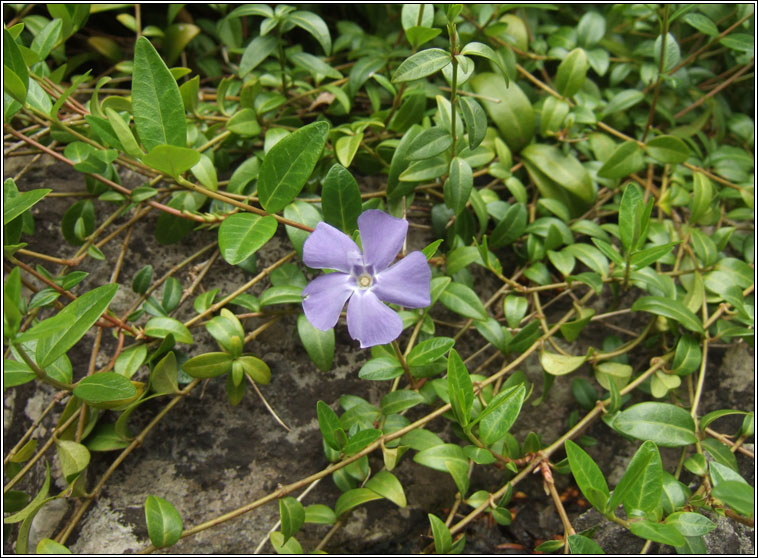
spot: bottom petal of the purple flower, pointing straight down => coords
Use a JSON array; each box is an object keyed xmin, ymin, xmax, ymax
[{"xmin": 347, "ymin": 290, "xmax": 403, "ymax": 349}]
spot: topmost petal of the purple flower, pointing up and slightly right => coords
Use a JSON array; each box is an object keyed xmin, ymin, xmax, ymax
[{"xmin": 358, "ymin": 209, "xmax": 408, "ymax": 273}]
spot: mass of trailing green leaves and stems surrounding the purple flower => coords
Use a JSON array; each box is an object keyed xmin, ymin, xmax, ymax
[{"xmin": 3, "ymin": 4, "xmax": 755, "ymax": 553}]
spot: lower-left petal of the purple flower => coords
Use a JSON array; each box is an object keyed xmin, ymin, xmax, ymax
[{"xmin": 303, "ymin": 273, "xmax": 355, "ymax": 331}]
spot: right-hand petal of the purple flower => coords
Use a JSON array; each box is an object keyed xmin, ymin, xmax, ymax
[{"xmin": 371, "ymin": 252, "xmax": 432, "ymax": 308}]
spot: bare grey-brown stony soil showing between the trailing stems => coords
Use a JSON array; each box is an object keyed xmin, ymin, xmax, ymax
[{"xmin": 4, "ymin": 156, "xmax": 755, "ymax": 554}]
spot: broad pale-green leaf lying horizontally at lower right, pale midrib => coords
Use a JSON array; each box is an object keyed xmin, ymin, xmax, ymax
[{"xmin": 613, "ymin": 401, "xmax": 697, "ymax": 448}]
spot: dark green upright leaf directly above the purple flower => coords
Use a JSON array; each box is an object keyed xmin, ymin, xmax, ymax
[{"xmin": 321, "ymin": 164, "xmax": 362, "ymax": 234}]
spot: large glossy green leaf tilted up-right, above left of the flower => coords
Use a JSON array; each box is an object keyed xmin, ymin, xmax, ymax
[{"xmin": 258, "ymin": 121, "xmax": 329, "ymax": 213}]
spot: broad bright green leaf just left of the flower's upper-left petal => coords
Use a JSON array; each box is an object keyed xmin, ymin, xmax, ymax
[{"xmin": 218, "ymin": 213, "xmax": 277, "ymax": 265}]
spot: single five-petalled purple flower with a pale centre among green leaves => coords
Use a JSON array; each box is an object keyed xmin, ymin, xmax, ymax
[{"xmin": 303, "ymin": 209, "xmax": 432, "ymax": 348}]
